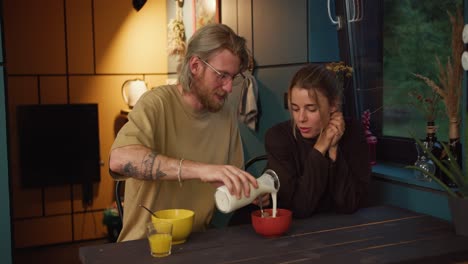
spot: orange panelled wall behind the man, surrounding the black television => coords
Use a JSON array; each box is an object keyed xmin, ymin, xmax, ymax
[{"xmin": 3, "ymin": 0, "xmax": 168, "ymax": 248}]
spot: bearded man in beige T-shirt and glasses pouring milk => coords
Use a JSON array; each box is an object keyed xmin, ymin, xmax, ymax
[{"xmin": 109, "ymin": 24, "xmax": 258, "ymax": 241}]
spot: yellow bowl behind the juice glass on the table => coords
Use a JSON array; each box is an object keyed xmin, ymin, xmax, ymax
[{"xmin": 151, "ymin": 209, "xmax": 195, "ymax": 245}]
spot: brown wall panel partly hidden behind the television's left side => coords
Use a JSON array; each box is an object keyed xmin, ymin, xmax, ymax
[{"xmin": 7, "ymin": 77, "xmax": 43, "ymax": 218}]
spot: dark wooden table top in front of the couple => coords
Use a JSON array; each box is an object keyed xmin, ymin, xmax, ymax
[{"xmin": 79, "ymin": 206, "xmax": 468, "ymax": 264}]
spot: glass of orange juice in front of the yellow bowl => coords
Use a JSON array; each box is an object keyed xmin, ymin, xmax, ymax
[{"xmin": 147, "ymin": 222, "xmax": 172, "ymax": 257}]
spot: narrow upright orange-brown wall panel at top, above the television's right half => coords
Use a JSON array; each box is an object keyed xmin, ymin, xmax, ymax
[{"xmin": 66, "ymin": 0, "xmax": 94, "ymax": 74}]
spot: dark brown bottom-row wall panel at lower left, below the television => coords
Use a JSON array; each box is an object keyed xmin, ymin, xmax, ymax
[{"xmin": 13, "ymin": 215, "xmax": 72, "ymax": 248}]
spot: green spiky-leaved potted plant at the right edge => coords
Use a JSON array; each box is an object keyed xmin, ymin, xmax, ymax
[{"xmin": 407, "ymin": 122, "xmax": 468, "ymax": 236}]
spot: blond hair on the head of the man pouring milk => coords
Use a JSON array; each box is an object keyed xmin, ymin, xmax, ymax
[{"xmin": 179, "ymin": 24, "xmax": 249, "ymax": 91}]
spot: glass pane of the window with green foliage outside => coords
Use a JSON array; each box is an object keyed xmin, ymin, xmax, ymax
[{"xmin": 383, "ymin": 0, "xmax": 462, "ymax": 141}]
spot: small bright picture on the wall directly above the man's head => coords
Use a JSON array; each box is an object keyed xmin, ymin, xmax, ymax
[{"xmin": 193, "ymin": 0, "xmax": 220, "ymax": 31}]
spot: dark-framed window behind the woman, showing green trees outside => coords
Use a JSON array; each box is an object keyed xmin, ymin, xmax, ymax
[{"xmin": 337, "ymin": 0, "xmax": 463, "ymax": 164}]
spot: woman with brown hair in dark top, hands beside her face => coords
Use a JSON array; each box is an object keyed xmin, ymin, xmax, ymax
[{"xmin": 265, "ymin": 64, "xmax": 371, "ymax": 218}]
